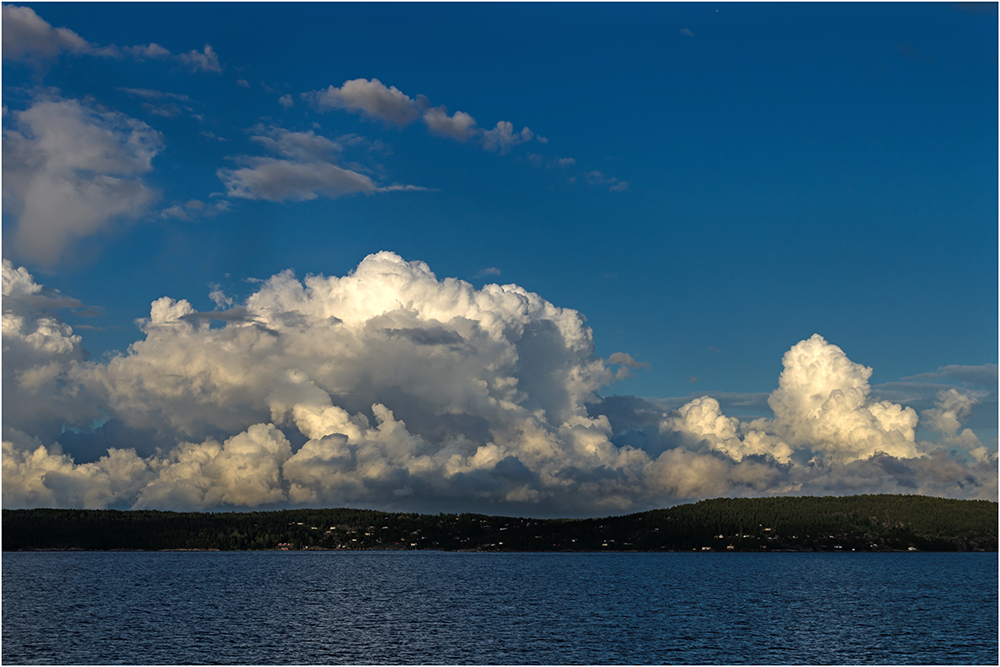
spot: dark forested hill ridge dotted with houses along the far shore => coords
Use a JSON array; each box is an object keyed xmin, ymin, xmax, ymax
[{"xmin": 2, "ymin": 495, "xmax": 998, "ymax": 552}]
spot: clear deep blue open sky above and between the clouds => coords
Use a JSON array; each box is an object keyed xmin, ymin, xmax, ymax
[{"xmin": 3, "ymin": 3, "xmax": 997, "ymax": 396}]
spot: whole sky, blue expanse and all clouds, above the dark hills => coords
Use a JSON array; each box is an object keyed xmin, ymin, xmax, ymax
[{"xmin": 2, "ymin": 3, "xmax": 998, "ymax": 516}]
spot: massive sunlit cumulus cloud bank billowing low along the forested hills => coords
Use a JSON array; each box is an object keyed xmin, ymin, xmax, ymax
[{"xmin": 3, "ymin": 252, "xmax": 996, "ymax": 515}]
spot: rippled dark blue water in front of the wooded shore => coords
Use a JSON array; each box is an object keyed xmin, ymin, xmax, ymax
[{"xmin": 2, "ymin": 552, "xmax": 998, "ymax": 665}]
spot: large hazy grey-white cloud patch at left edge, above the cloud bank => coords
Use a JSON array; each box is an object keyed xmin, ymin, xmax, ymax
[{"xmin": 3, "ymin": 96, "xmax": 163, "ymax": 267}]
